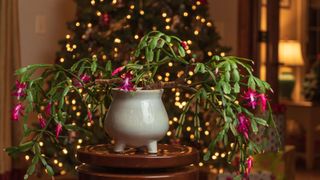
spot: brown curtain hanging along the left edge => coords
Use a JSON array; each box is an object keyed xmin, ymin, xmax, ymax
[{"xmin": 0, "ymin": 0, "xmax": 20, "ymax": 180}]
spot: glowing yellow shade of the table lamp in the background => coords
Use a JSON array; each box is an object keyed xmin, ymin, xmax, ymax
[{"xmin": 278, "ymin": 40, "xmax": 303, "ymax": 66}]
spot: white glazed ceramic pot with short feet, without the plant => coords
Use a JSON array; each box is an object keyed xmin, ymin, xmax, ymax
[{"xmin": 104, "ymin": 89, "xmax": 169, "ymax": 153}]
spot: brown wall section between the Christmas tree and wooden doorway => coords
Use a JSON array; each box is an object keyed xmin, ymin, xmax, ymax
[{"xmin": 208, "ymin": 0, "xmax": 238, "ymax": 54}]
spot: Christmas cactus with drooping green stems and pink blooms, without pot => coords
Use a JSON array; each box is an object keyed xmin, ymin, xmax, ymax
[{"xmin": 6, "ymin": 31, "xmax": 274, "ymax": 178}]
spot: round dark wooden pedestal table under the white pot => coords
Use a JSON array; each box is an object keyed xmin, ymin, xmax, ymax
[{"xmin": 77, "ymin": 144, "xmax": 199, "ymax": 180}]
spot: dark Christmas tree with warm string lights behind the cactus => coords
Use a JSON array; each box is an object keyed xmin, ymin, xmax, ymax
[{"xmin": 44, "ymin": 0, "xmax": 232, "ymax": 174}]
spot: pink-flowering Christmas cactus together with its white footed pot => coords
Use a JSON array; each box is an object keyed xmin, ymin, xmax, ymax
[{"xmin": 6, "ymin": 31, "xmax": 273, "ymax": 178}]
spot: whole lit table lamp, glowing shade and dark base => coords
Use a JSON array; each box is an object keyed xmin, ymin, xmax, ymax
[{"xmin": 278, "ymin": 40, "xmax": 303, "ymax": 100}]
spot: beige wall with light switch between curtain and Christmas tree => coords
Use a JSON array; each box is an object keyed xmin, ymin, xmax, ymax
[{"xmin": 19, "ymin": 0, "xmax": 75, "ymax": 66}]
